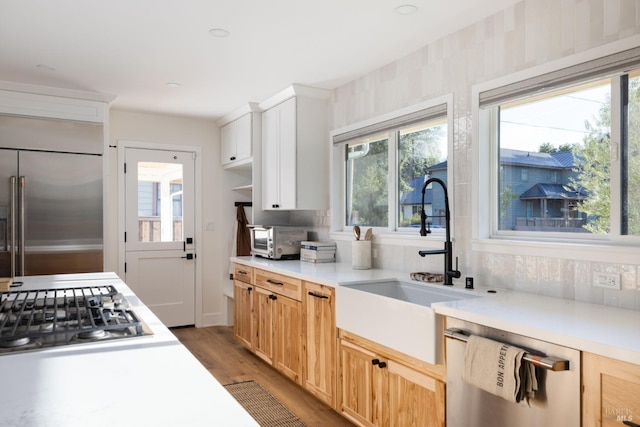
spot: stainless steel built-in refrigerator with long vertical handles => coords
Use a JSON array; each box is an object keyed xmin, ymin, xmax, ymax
[{"xmin": 0, "ymin": 117, "xmax": 103, "ymax": 277}]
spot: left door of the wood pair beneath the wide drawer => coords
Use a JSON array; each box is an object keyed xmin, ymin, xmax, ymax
[{"xmin": 253, "ymin": 286, "xmax": 275, "ymax": 364}]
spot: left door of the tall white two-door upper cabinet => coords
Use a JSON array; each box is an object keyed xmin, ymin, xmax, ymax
[{"xmin": 262, "ymin": 106, "xmax": 280, "ymax": 210}]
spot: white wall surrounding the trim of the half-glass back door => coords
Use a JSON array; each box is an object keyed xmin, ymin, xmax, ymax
[{"xmin": 105, "ymin": 110, "xmax": 228, "ymax": 325}]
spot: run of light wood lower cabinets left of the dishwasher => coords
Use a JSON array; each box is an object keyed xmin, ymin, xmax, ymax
[{"xmin": 234, "ymin": 266, "xmax": 445, "ymax": 427}]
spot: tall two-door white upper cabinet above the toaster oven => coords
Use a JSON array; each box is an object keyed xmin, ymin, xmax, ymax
[{"xmin": 260, "ymin": 85, "xmax": 329, "ymax": 210}]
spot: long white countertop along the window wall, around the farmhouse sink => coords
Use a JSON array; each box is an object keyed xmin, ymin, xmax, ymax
[{"xmin": 231, "ymin": 257, "xmax": 640, "ymax": 365}]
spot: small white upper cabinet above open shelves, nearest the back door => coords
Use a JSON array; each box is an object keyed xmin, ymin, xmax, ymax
[{"xmin": 220, "ymin": 113, "xmax": 253, "ymax": 166}]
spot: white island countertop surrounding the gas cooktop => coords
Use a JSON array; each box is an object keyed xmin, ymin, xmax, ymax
[{"xmin": 0, "ymin": 273, "xmax": 258, "ymax": 427}]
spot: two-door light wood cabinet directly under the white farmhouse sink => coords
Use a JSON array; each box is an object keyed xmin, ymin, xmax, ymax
[{"xmin": 338, "ymin": 339, "xmax": 445, "ymax": 427}]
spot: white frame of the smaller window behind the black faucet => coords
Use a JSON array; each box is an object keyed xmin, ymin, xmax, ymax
[{"xmin": 330, "ymin": 94, "xmax": 455, "ymax": 244}]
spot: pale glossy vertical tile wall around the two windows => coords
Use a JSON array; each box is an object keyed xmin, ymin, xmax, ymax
[{"xmin": 298, "ymin": 0, "xmax": 640, "ymax": 310}]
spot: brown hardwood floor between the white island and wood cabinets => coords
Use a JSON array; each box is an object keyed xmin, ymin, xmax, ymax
[{"xmin": 172, "ymin": 326, "xmax": 353, "ymax": 427}]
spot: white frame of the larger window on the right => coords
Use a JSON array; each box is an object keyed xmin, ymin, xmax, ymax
[{"xmin": 471, "ymin": 40, "xmax": 640, "ymax": 262}]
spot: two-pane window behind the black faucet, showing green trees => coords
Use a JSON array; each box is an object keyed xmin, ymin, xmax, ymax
[{"xmin": 334, "ymin": 100, "xmax": 451, "ymax": 233}]
